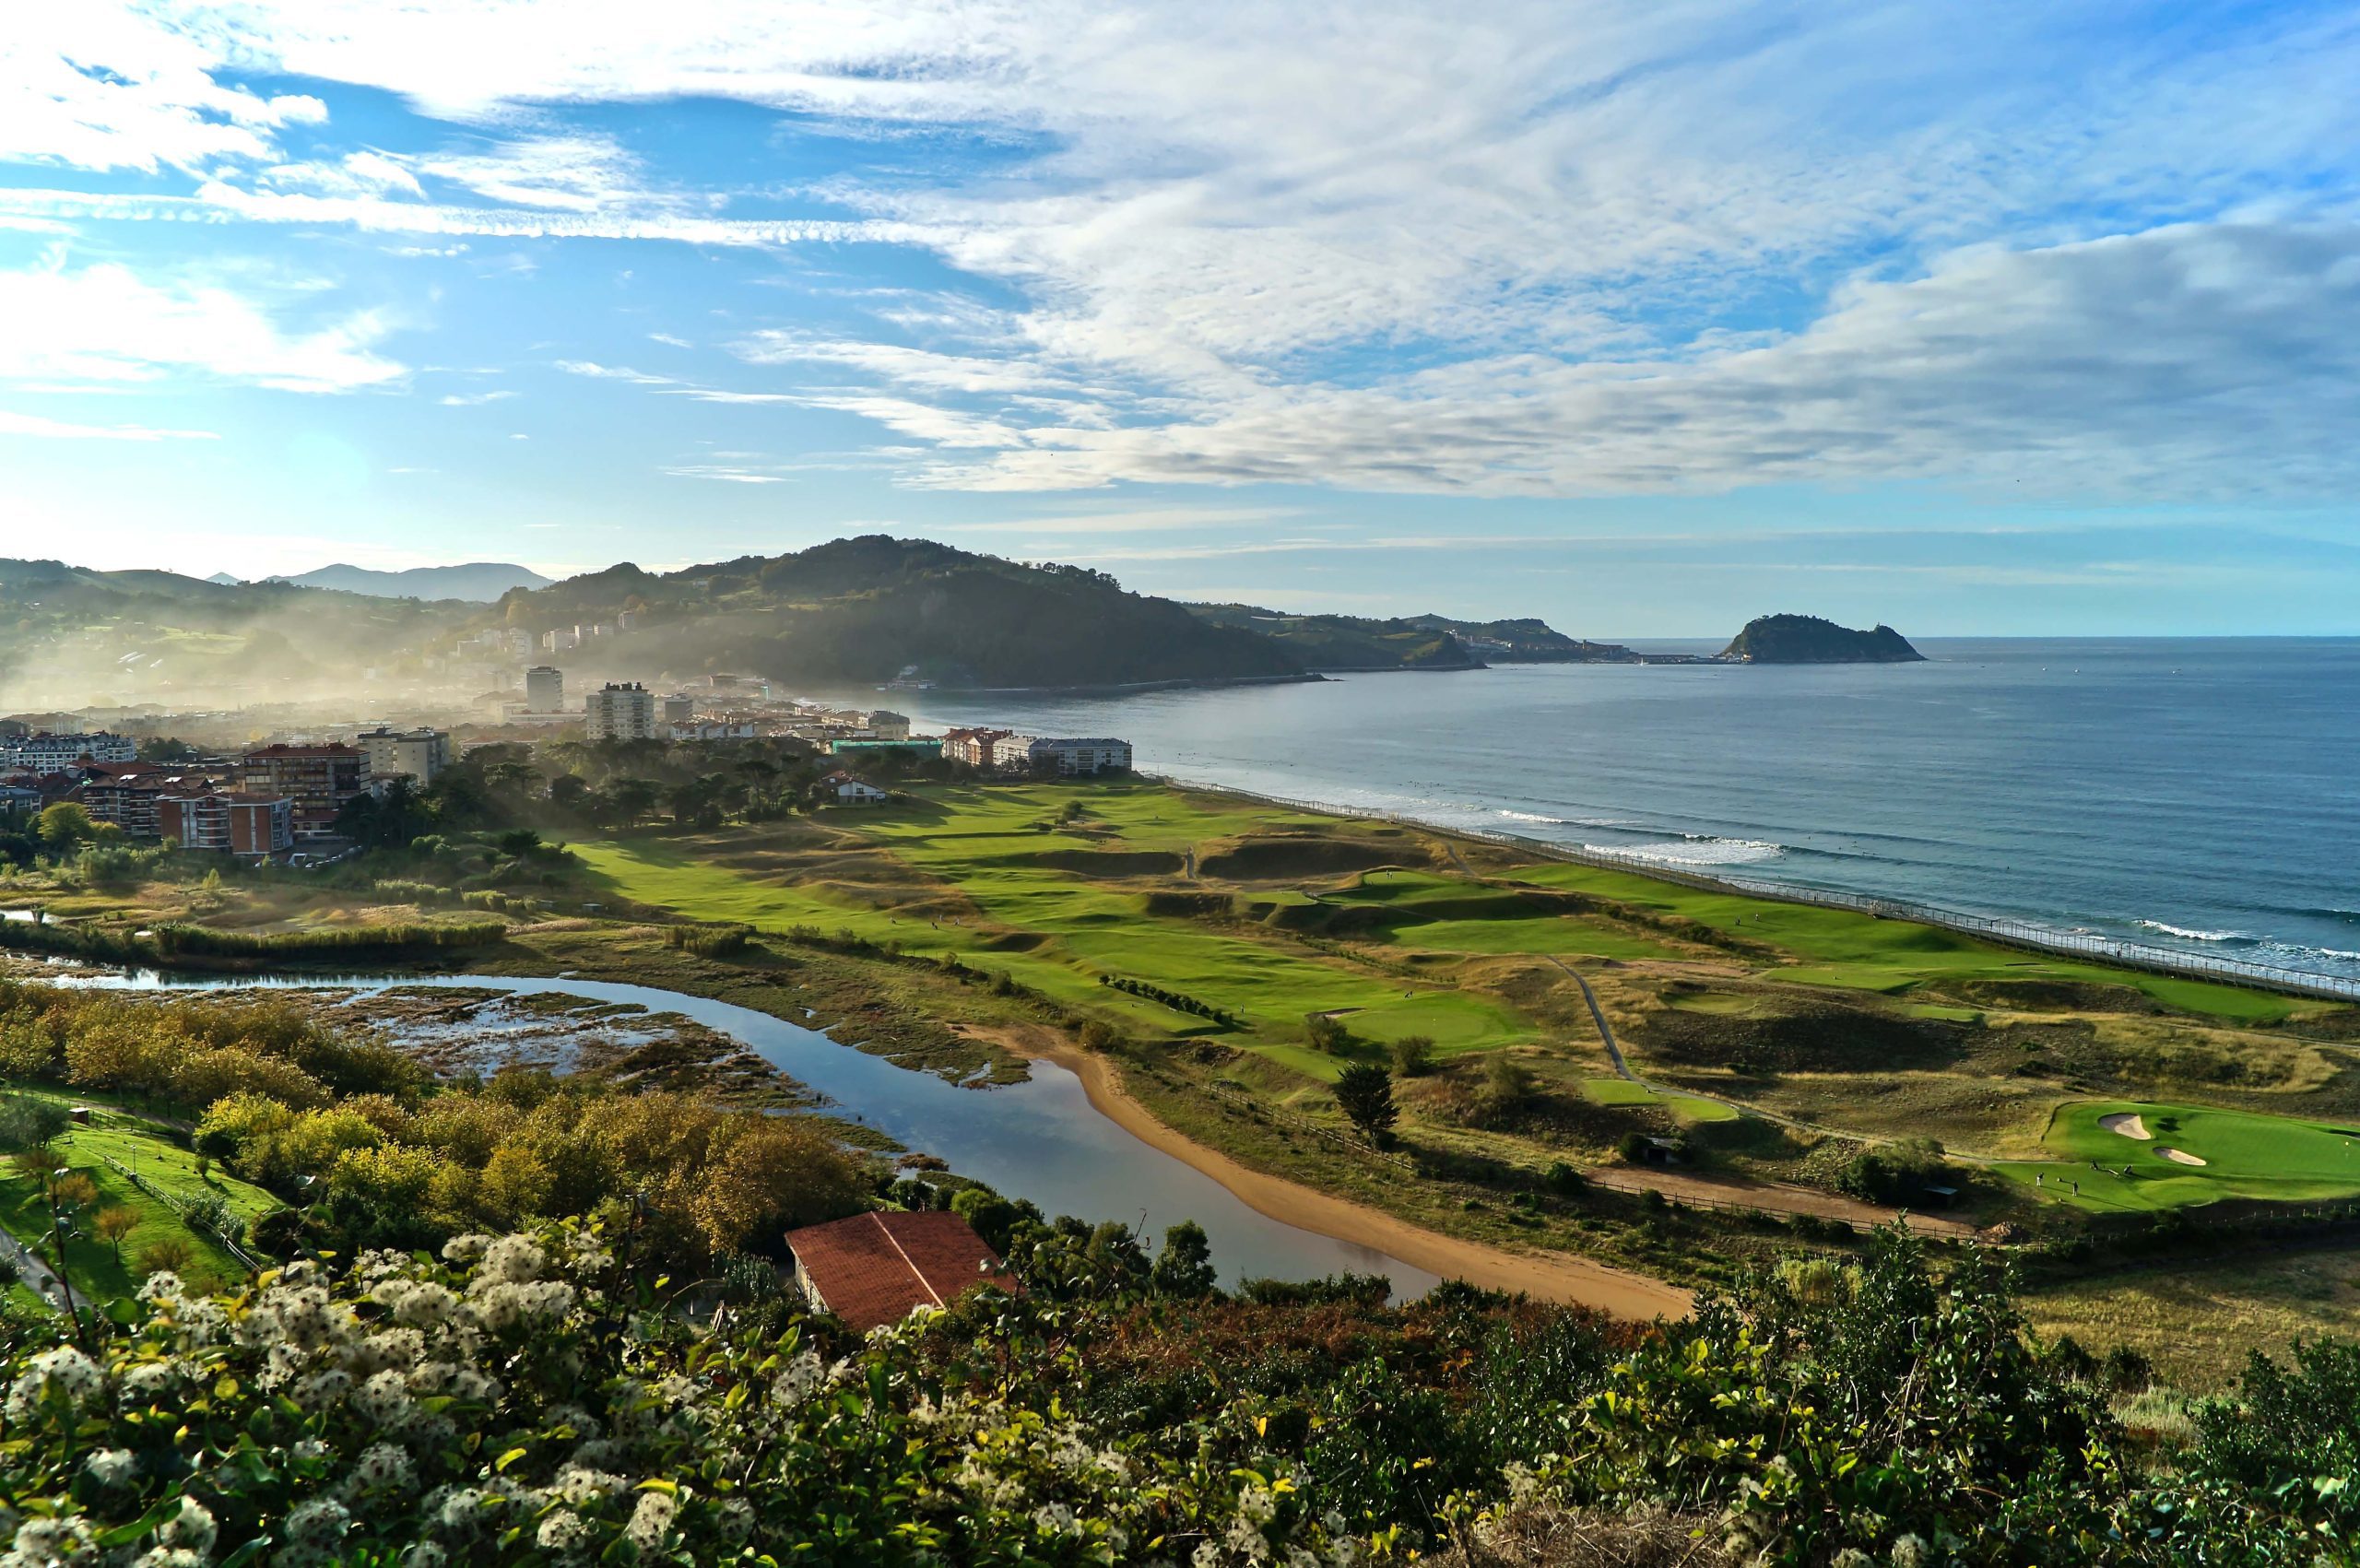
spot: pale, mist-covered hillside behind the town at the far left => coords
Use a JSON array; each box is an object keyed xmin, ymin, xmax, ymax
[{"xmin": 0, "ymin": 560, "xmax": 465, "ymax": 709}]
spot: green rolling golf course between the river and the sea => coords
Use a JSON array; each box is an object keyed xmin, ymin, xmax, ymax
[{"xmin": 572, "ymin": 782, "xmax": 2360, "ymax": 1214}]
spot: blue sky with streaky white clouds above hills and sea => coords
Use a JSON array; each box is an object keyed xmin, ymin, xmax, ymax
[{"xmin": 0, "ymin": 0, "xmax": 2360, "ymax": 638}]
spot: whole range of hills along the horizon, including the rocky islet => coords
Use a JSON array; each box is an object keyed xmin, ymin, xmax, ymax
[{"xmin": 0, "ymin": 534, "xmax": 1918, "ymax": 709}]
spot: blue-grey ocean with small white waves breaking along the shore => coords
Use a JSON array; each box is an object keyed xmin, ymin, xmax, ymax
[{"xmin": 892, "ymin": 638, "xmax": 2360, "ymax": 975}]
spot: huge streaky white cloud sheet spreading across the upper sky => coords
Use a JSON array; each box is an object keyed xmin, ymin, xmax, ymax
[{"xmin": 14, "ymin": 0, "xmax": 2360, "ymax": 496}]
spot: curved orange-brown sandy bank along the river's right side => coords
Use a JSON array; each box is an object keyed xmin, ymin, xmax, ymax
[{"xmin": 961, "ymin": 1025, "xmax": 1693, "ymax": 1320}]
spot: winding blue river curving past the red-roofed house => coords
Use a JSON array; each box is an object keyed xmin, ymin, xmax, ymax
[{"xmin": 45, "ymin": 971, "xmax": 1440, "ymax": 1302}]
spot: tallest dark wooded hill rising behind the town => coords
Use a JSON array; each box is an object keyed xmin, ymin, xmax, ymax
[{"xmin": 481, "ymin": 534, "xmax": 1305, "ymax": 687}]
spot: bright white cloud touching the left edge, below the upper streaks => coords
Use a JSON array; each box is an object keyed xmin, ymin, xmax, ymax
[{"xmin": 0, "ymin": 255, "xmax": 406, "ymax": 392}]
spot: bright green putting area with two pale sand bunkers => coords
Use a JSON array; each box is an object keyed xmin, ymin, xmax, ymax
[{"xmin": 1994, "ymin": 1101, "xmax": 2360, "ymax": 1209}]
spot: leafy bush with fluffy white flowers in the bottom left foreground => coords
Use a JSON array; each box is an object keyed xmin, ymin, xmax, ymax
[{"xmin": 0, "ymin": 1226, "xmax": 1360, "ymax": 1568}]
